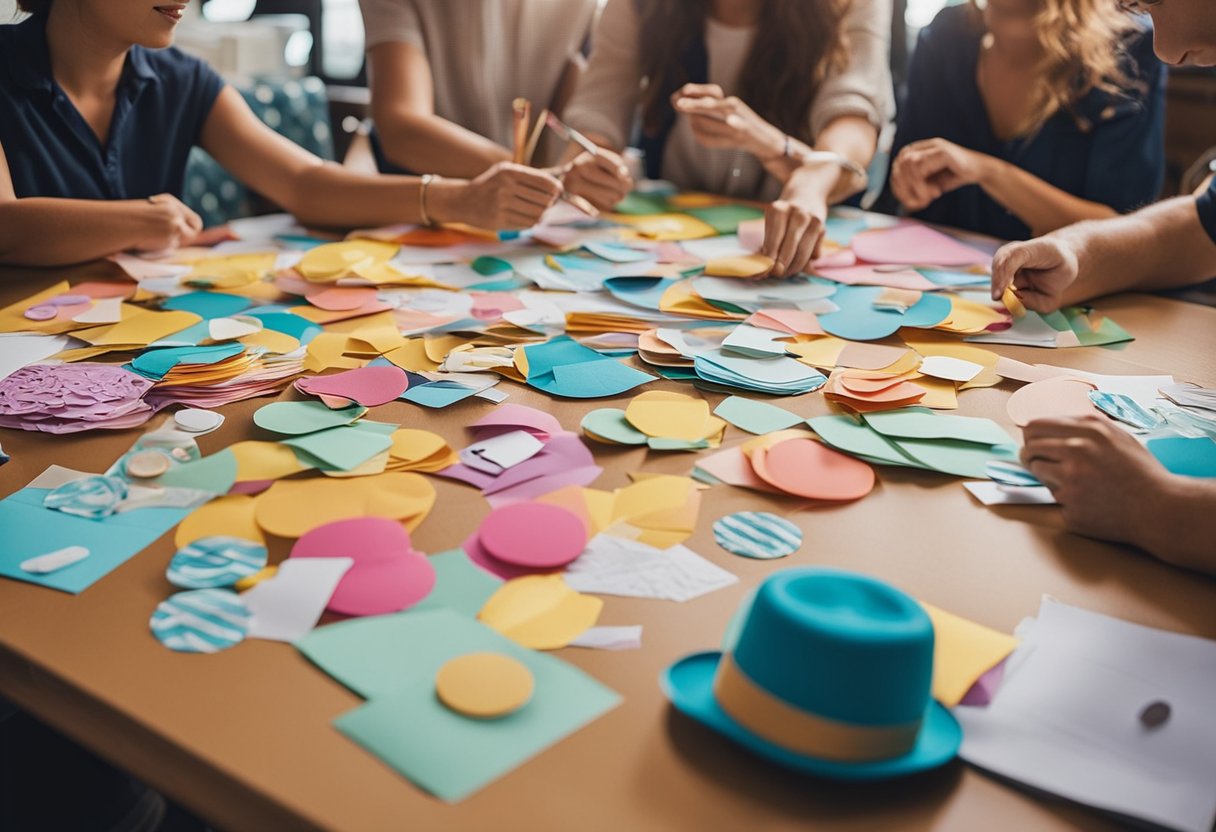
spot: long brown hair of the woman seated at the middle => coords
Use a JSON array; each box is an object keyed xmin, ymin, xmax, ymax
[{"xmin": 640, "ymin": 0, "xmax": 850, "ymax": 142}]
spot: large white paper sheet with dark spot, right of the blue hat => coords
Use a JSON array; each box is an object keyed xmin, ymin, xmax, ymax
[{"xmin": 955, "ymin": 600, "xmax": 1216, "ymax": 832}]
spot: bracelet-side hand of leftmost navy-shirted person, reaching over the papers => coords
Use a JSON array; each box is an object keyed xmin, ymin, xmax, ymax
[{"xmin": 445, "ymin": 162, "xmax": 562, "ymax": 231}]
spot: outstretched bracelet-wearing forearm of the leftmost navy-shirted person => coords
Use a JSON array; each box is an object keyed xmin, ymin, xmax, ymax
[{"xmin": 283, "ymin": 163, "xmax": 466, "ymax": 227}]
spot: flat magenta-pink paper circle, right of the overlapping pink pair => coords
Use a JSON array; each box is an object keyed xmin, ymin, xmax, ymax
[{"xmin": 479, "ymin": 502, "xmax": 587, "ymax": 569}]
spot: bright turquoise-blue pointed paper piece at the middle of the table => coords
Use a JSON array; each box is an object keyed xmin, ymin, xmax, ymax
[{"xmin": 523, "ymin": 336, "xmax": 654, "ymax": 399}]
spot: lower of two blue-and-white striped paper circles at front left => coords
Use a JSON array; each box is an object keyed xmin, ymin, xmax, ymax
[{"xmin": 148, "ymin": 590, "xmax": 249, "ymax": 653}]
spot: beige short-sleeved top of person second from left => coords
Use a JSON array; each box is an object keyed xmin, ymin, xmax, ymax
[{"xmin": 359, "ymin": 0, "xmax": 596, "ymax": 147}]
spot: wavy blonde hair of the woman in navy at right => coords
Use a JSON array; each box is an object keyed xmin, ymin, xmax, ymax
[{"xmin": 972, "ymin": 0, "xmax": 1144, "ymax": 135}]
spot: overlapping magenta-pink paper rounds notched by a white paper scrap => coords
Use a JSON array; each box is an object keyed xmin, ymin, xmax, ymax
[{"xmin": 291, "ymin": 517, "xmax": 435, "ymax": 615}]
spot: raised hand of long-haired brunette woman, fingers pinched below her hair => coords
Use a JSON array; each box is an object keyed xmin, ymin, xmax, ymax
[{"xmin": 671, "ymin": 84, "xmax": 786, "ymax": 161}]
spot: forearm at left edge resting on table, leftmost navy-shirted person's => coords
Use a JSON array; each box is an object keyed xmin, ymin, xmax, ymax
[{"xmin": 0, "ymin": 197, "xmax": 159, "ymax": 266}]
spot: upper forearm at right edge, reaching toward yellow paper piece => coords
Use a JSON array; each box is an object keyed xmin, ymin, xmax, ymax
[{"xmin": 1047, "ymin": 197, "xmax": 1216, "ymax": 305}]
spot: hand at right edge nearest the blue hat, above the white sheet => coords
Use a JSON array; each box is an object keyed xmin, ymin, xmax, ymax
[{"xmin": 1021, "ymin": 415, "xmax": 1173, "ymax": 549}]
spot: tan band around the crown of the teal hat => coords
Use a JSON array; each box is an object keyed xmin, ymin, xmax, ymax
[{"xmin": 714, "ymin": 653, "xmax": 921, "ymax": 763}]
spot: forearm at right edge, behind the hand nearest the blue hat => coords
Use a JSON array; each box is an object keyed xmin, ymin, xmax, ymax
[{"xmin": 1135, "ymin": 474, "xmax": 1216, "ymax": 575}]
